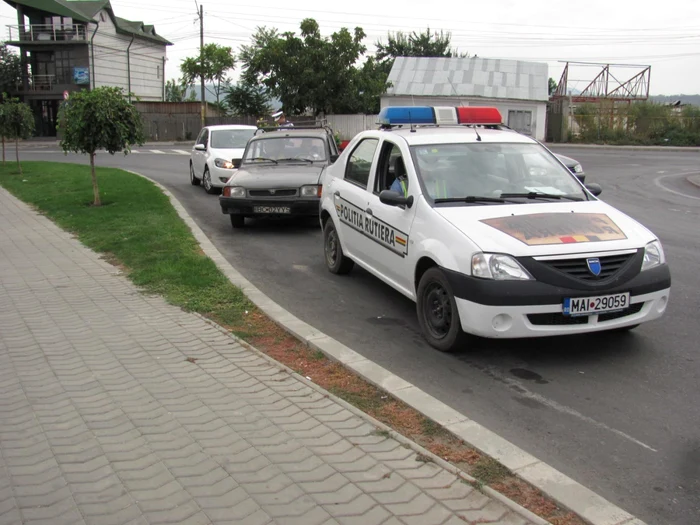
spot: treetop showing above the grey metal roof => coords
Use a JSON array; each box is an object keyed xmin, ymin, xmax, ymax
[{"xmin": 375, "ymin": 27, "xmax": 469, "ymax": 75}]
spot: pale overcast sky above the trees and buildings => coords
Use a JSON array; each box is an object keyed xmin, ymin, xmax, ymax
[{"xmin": 0, "ymin": 0, "xmax": 700, "ymax": 95}]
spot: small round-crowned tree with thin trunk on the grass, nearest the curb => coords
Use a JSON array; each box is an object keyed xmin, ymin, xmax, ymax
[{"xmin": 58, "ymin": 87, "xmax": 145, "ymax": 206}]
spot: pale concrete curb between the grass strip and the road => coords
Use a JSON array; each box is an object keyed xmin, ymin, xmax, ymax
[{"xmin": 130, "ymin": 170, "xmax": 646, "ymax": 525}]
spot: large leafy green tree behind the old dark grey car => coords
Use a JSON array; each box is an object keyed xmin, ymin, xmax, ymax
[{"xmin": 239, "ymin": 18, "xmax": 386, "ymax": 115}]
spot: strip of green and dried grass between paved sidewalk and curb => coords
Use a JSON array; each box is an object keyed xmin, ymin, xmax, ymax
[{"xmin": 0, "ymin": 162, "xmax": 584, "ymax": 525}]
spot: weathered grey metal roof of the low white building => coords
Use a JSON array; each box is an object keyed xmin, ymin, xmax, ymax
[{"xmin": 386, "ymin": 57, "xmax": 549, "ymax": 102}]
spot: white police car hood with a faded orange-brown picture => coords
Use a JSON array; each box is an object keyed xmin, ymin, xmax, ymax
[{"xmin": 434, "ymin": 201, "xmax": 656, "ymax": 257}]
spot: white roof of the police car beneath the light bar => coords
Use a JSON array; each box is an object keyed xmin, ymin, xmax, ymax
[{"xmin": 363, "ymin": 125, "xmax": 537, "ymax": 146}]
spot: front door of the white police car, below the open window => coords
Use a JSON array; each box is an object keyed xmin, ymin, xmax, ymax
[{"xmin": 366, "ymin": 138, "xmax": 420, "ymax": 296}]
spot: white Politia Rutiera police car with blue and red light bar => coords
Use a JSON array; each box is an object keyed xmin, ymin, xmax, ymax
[{"xmin": 320, "ymin": 106, "xmax": 671, "ymax": 351}]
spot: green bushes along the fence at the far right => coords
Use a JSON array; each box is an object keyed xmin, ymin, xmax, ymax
[{"xmin": 573, "ymin": 102, "xmax": 700, "ymax": 146}]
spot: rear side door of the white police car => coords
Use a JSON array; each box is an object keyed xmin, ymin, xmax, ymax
[{"xmin": 331, "ymin": 137, "xmax": 379, "ymax": 268}]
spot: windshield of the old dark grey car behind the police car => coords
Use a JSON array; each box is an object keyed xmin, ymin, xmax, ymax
[{"xmin": 243, "ymin": 137, "xmax": 326, "ymax": 164}]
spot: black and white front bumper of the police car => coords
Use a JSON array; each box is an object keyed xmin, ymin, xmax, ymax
[{"xmin": 446, "ymin": 265, "xmax": 671, "ymax": 339}]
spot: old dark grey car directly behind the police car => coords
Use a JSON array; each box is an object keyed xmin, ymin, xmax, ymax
[{"xmin": 219, "ymin": 126, "xmax": 338, "ymax": 228}]
